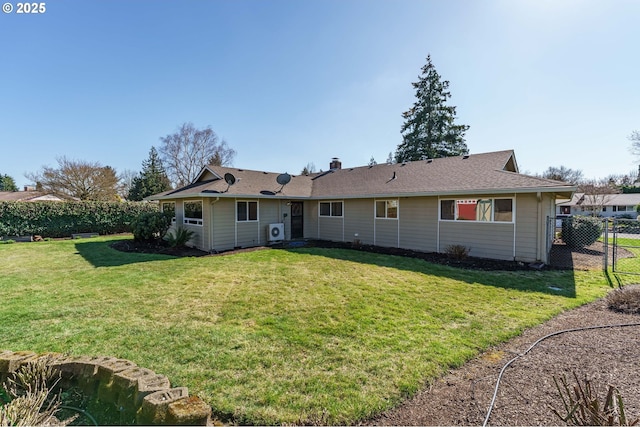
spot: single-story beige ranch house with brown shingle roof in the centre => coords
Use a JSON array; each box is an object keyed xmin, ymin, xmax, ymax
[{"xmin": 148, "ymin": 150, "xmax": 576, "ymax": 262}]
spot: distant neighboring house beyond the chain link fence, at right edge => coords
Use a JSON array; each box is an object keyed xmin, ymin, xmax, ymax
[{"xmin": 556, "ymin": 193, "xmax": 640, "ymax": 219}]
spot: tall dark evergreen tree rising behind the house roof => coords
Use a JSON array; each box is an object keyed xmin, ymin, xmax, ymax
[{"xmin": 396, "ymin": 55, "xmax": 469, "ymax": 162}]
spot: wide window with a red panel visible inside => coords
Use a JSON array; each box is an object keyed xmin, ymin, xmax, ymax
[{"xmin": 440, "ymin": 199, "xmax": 513, "ymax": 222}]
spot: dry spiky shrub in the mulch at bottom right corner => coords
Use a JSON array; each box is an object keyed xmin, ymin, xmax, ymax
[{"xmin": 551, "ymin": 372, "xmax": 639, "ymax": 426}]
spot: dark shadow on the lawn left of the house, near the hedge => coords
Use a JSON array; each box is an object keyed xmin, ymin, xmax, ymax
[{"xmin": 75, "ymin": 241, "xmax": 175, "ymax": 267}]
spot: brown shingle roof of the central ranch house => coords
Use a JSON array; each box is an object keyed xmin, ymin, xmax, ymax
[{"xmin": 152, "ymin": 150, "xmax": 575, "ymax": 199}]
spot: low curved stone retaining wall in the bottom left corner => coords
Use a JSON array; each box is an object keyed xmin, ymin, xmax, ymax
[{"xmin": 0, "ymin": 350, "xmax": 211, "ymax": 425}]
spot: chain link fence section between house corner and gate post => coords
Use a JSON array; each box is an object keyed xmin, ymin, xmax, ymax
[{"xmin": 547, "ymin": 216, "xmax": 613, "ymax": 270}]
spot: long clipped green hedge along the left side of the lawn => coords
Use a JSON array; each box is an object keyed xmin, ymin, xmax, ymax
[{"xmin": 0, "ymin": 202, "xmax": 158, "ymax": 237}]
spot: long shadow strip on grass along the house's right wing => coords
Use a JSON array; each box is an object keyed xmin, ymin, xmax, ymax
[{"xmin": 282, "ymin": 243, "xmax": 577, "ymax": 298}]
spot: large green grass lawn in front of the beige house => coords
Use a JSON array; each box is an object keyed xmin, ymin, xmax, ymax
[{"xmin": 0, "ymin": 237, "xmax": 610, "ymax": 424}]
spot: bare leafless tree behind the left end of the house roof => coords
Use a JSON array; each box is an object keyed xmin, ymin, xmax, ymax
[{"xmin": 160, "ymin": 123, "xmax": 236, "ymax": 187}]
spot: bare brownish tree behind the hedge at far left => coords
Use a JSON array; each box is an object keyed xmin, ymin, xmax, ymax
[{"xmin": 25, "ymin": 156, "xmax": 118, "ymax": 201}]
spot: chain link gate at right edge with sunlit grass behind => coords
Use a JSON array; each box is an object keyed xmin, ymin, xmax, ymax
[{"xmin": 611, "ymin": 218, "xmax": 640, "ymax": 274}]
